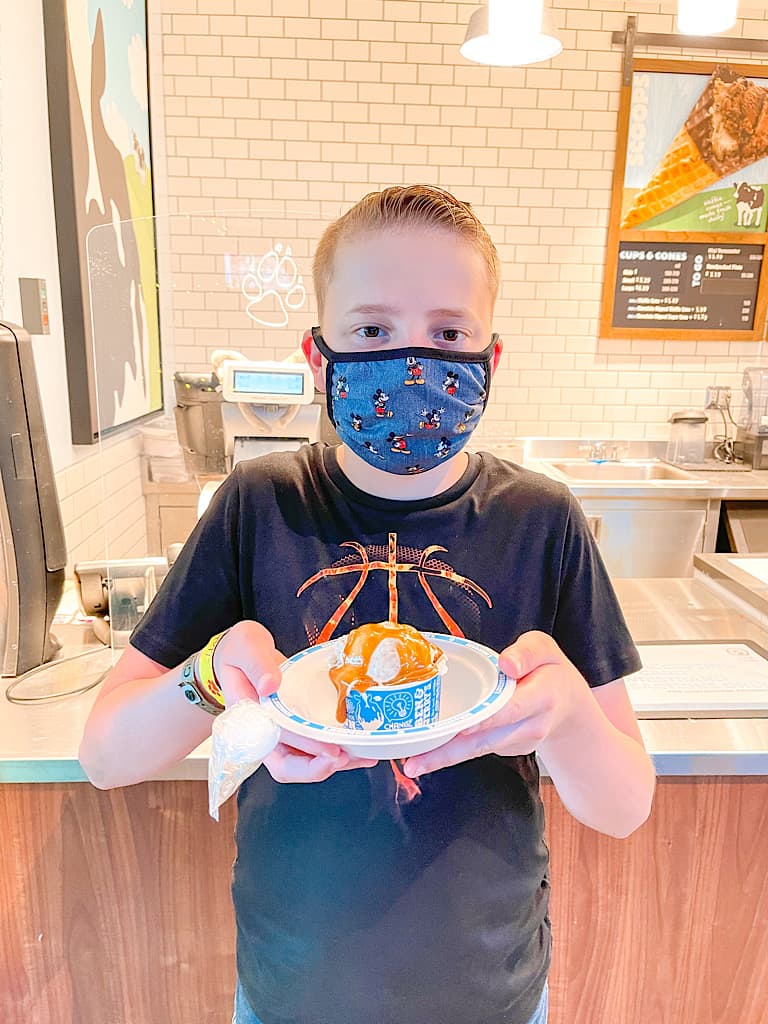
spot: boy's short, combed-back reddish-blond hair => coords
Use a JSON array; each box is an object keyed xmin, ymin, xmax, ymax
[{"xmin": 312, "ymin": 185, "xmax": 499, "ymax": 316}]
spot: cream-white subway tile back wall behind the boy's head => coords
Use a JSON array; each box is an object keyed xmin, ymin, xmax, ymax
[{"xmin": 156, "ymin": 0, "xmax": 766, "ymax": 439}]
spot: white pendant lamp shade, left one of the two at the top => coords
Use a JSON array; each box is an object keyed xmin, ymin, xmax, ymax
[{"xmin": 459, "ymin": 0, "xmax": 562, "ymax": 68}]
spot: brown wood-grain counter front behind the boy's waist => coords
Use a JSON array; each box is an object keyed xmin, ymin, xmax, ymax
[{"xmin": 0, "ymin": 777, "xmax": 768, "ymax": 1024}]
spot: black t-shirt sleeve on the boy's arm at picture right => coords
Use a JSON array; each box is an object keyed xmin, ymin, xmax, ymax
[{"xmin": 553, "ymin": 496, "xmax": 641, "ymax": 686}]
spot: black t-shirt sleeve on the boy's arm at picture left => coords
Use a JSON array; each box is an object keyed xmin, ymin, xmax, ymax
[{"xmin": 130, "ymin": 468, "xmax": 243, "ymax": 669}]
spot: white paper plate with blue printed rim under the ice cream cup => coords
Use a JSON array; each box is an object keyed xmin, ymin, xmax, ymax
[{"xmin": 261, "ymin": 633, "xmax": 515, "ymax": 760}]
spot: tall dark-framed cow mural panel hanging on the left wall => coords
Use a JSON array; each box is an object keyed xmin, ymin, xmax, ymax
[{"xmin": 43, "ymin": 0, "xmax": 163, "ymax": 444}]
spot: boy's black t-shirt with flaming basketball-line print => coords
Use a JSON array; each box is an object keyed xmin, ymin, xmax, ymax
[{"xmin": 131, "ymin": 444, "xmax": 640, "ymax": 1024}]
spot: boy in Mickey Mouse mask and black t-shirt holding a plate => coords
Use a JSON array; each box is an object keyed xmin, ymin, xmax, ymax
[{"xmin": 81, "ymin": 186, "xmax": 653, "ymax": 1024}]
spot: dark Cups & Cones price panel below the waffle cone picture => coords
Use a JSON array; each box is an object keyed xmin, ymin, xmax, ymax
[{"xmin": 613, "ymin": 242, "xmax": 764, "ymax": 332}]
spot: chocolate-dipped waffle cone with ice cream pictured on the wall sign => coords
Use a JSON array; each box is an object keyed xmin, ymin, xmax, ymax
[{"xmin": 622, "ymin": 65, "xmax": 768, "ymax": 228}]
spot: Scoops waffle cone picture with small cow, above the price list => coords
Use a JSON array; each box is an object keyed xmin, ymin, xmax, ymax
[{"xmin": 620, "ymin": 63, "xmax": 768, "ymax": 233}]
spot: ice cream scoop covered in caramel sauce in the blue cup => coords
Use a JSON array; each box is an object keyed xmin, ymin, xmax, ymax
[{"xmin": 329, "ymin": 623, "xmax": 445, "ymax": 722}]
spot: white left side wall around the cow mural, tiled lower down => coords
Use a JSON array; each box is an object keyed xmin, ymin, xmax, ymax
[{"xmin": 0, "ymin": 0, "xmax": 146, "ymax": 571}]
